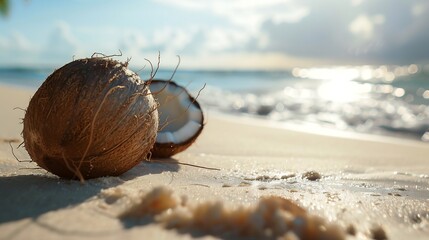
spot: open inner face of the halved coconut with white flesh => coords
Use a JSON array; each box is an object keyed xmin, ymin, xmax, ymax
[{"xmin": 150, "ymin": 81, "xmax": 203, "ymax": 144}]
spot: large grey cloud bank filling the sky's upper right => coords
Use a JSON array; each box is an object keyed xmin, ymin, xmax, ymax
[{"xmin": 249, "ymin": 0, "xmax": 429, "ymax": 64}]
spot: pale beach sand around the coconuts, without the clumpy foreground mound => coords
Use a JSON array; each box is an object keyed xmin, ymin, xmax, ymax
[{"xmin": 0, "ymin": 83, "xmax": 429, "ymax": 239}]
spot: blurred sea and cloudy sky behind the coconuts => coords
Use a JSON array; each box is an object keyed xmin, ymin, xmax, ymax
[{"xmin": 0, "ymin": 0, "xmax": 429, "ymax": 141}]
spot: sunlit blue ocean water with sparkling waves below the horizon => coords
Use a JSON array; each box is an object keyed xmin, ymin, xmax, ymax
[{"xmin": 0, "ymin": 64, "xmax": 429, "ymax": 141}]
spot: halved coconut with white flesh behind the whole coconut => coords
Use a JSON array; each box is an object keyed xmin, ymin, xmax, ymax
[{"xmin": 149, "ymin": 80, "xmax": 204, "ymax": 158}]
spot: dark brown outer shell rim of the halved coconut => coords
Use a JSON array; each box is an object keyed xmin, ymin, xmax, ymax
[{"xmin": 151, "ymin": 79, "xmax": 204, "ymax": 158}]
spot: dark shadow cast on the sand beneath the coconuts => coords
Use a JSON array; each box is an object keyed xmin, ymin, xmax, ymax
[{"xmin": 0, "ymin": 159, "xmax": 180, "ymax": 224}]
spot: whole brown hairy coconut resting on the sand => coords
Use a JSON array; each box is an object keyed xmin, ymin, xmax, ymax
[{"xmin": 23, "ymin": 58, "xmax": 158, "ymax": 181}]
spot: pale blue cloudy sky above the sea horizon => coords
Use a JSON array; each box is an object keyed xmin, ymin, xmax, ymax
[{"xmin": 0, "ymin": 0, "xmax": 429, "ymax": 70}]
